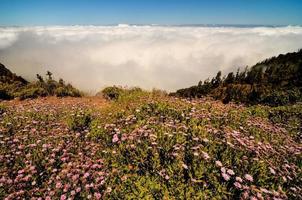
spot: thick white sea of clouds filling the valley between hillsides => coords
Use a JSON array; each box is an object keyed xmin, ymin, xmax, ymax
[{"xmin": 0, "ymin": 25, "xmax": 302, "ymax": 92}]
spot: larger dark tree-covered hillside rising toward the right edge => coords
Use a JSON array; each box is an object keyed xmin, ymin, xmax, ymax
[{"xmin": 171, "ymin": 50, "xmax": 302, "ymax": 106}]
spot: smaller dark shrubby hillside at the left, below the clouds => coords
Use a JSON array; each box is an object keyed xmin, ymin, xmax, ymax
[{"xmin": 0, "ymin": 64, "xmax": 82, "ymax": 100}]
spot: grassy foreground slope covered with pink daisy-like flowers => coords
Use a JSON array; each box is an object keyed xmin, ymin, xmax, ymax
[{"xmin": 0, "ymin": 91, "xmax": 302, "ymax": 199}]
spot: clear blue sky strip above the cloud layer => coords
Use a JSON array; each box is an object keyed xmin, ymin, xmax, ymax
[{"xmin": 0, "ymin": 0, "xmax": 302, "ymax": 26}]
